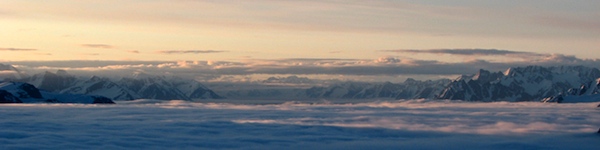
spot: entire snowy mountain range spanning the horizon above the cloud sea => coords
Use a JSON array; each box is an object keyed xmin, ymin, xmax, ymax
[{"xmin": 0, "ymin": 64, "xmax": 600, "ymax": 102}]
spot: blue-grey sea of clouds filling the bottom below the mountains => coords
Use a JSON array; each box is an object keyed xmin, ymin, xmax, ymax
[{"xmin": 0, "ymin": 100, "xmax": 600, "ymax": 149}]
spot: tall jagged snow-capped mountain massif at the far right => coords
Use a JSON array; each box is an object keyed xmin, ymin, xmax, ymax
[{"xmin": 437, "ymin": 66, "xmax": 600, "ymax": 101}]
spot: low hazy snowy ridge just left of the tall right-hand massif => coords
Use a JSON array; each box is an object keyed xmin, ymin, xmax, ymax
[{"xmin": 306, "ymin": 79, "xmax": 450, "ymax": 99}]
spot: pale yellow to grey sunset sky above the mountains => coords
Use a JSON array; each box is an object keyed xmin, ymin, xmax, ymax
[{"xmin": 0, "ymin": 0, "xmax": 600, "ymax": 82}]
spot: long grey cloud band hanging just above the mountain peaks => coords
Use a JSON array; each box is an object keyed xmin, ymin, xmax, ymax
[{"xmin": 4, "ymin": 49, "xmax": 600, "ymax": 80}]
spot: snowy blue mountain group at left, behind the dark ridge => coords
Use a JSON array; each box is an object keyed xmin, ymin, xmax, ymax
[{"xmin": 9, "ymin": 70, "xmax": 222, "ymax": 100}]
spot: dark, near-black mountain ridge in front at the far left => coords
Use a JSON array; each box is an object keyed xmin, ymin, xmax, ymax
[{"xmin": 0, "ymin": 82, "xmax": 114, "ymax": 104}]
